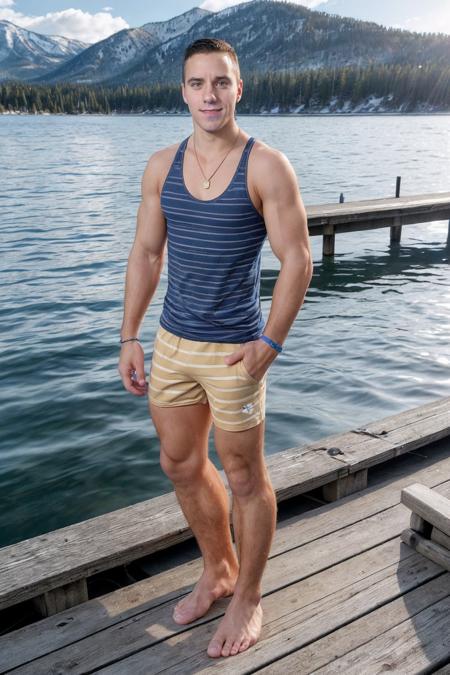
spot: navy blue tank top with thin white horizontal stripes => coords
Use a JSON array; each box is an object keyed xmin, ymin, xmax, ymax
[{"xmin": 159, "ymin": 137, "xmax": 267, "ymax": 343}]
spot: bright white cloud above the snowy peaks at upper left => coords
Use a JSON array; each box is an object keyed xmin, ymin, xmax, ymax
[{"xmin": 0, "ymin": 0, "xmax": 129, "ymax": 43}]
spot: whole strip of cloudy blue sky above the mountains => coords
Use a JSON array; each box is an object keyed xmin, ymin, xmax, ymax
[{"xmin": 0, "ymin": 0, "xmax": 450, "ymax": 43}]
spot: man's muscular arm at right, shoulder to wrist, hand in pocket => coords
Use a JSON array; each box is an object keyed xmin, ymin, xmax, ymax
[{"xmin": 257, "ymin": 149, "xmax": 313, "ymax": 349}]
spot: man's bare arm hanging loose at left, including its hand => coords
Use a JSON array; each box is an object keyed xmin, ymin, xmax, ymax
[{"xmin": 118, "ymin": 153, "xmax": 167, "ymax": 396}]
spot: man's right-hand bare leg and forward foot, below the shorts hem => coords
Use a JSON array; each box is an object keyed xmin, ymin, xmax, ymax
[{"xmin": 208, "ymin": 422, "xmax": 277, "ymax": 657}]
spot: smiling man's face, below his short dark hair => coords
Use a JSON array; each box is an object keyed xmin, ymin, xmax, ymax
[{"xmin": 181, "ymin": 52, "xmax": 243, "ymax": 131}]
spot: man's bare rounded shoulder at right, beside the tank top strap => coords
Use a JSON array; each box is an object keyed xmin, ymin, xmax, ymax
[{"xmin": 249, "ymin": 139, "xmax": 298, "ymax": 198}]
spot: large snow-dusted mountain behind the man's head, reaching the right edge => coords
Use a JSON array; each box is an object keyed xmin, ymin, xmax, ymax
[{"xmin": 111, "ymin": 0, "xmax": 450, "ymax": 85}]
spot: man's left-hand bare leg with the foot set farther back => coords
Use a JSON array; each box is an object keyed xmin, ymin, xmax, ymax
[{"xmin": 150, "ymin": 404, "xmax": 243, "ymax": 624}]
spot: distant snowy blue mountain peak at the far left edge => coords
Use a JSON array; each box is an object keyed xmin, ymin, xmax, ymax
[{"xmin": 0, "ymin": 21, "xmax": 89, "ymax": 79}]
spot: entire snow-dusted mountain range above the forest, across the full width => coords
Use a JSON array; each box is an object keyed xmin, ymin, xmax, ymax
[{"xmin": 0, "ymin": 0, "xmax": 450, "ymax": 85}]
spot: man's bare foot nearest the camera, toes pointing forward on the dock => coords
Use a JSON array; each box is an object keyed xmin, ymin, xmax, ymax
[{"xmin": 207, "ymin": 596, "xmax": 263, "ymax": 658}]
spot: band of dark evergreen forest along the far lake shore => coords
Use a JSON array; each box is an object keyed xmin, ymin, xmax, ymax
[{"xmin": 0, "ymin": 64, "xmax": 450, "ymax": 115}]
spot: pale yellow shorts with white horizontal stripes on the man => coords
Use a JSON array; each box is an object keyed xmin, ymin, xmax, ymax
[{"xmin": 148, "ymin": 325, "xmax": 267, "ymax": 431}]
